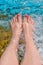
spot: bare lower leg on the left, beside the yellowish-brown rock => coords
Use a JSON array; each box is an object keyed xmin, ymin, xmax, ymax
[{"xmin": 1, "ymin": 39, "xmax": 18, "ymax": 65}]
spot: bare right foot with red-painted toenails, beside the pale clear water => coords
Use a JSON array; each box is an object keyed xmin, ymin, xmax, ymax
[{"xmin": 23, "ymin": 15, "xmax": 34, "ymax": 42}]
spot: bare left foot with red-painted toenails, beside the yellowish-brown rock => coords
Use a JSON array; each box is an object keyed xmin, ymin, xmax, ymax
[{"xmin": 11, "ymin": 14, "xmax": 22, "ymax": 40}]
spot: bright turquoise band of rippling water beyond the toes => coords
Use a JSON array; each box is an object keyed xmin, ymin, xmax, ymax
[{"xmin": 0, "ymin": 0, "xmax": 43, "ymax": 15}]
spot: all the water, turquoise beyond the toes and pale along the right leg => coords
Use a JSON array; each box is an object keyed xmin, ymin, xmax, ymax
[{"xmin": 0, "ymin": 0, "xmax": 43, "ymax": 63}]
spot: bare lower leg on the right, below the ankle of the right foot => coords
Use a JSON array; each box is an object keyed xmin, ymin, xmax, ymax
[{"xmin": 22, "ymin": 37, "xmax": 41, "ymax": 65}]
